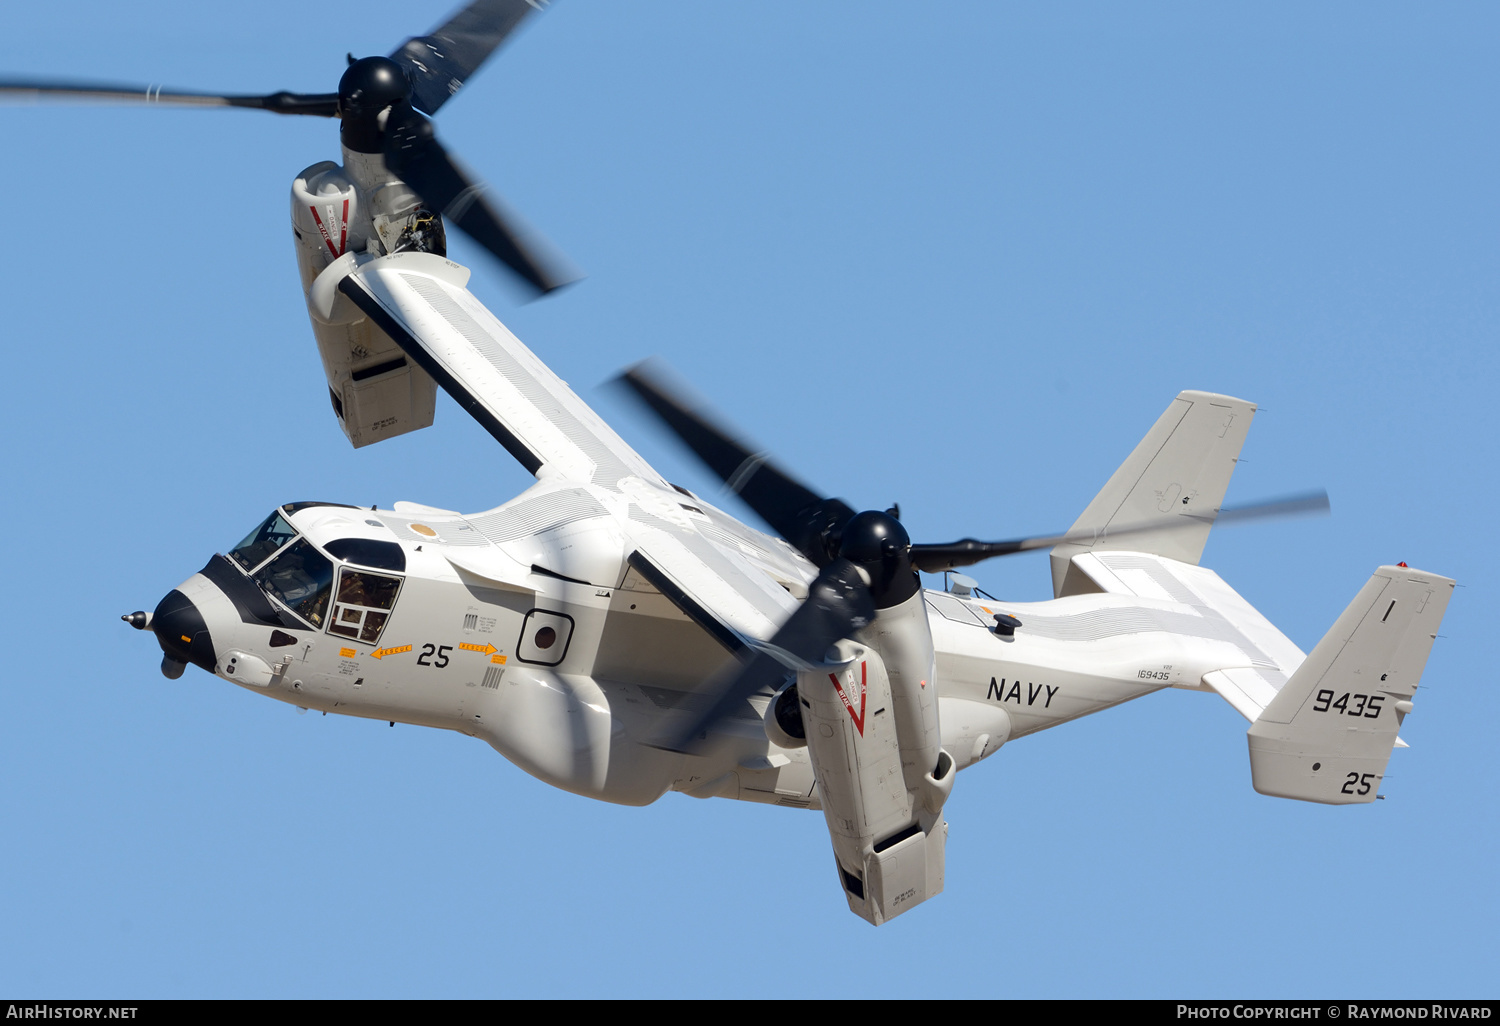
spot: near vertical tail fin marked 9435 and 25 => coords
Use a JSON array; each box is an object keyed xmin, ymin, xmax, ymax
[{"xmin": 1250, "ymin": 567, "xmax": 1454, "ymax": 806}]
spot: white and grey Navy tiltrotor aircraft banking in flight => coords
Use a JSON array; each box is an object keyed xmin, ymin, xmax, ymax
[{"xmin": 2, "ymin": 0, "xmax": 1454, "ymax": 924}]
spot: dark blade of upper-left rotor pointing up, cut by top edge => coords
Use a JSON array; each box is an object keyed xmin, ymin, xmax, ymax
[{"xmin": 390, "ymin": 0, "xmax": 549, "ymax": 114}]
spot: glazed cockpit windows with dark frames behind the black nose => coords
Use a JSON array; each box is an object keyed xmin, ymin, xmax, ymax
[{"xmin": 230, "ymin": 503, "xmax": 407, "ymax": 645}]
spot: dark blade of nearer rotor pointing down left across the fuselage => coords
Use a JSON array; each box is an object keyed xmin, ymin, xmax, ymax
[{"xmin": 660, "ymin": 560, "xmax": 875, "ymax": 752}]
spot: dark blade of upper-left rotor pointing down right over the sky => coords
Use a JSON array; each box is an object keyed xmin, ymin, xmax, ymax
[{"xmin": 386, "ymin": 104, "xmax": 576, "ymax": 293}]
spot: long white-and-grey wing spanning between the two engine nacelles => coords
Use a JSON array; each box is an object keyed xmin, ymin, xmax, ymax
[{"xmin": 338, "ymin": 254, "xmax": 813, "ymax": 650}]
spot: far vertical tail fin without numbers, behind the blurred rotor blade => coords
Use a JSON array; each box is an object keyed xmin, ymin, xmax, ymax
[{"xmin": 1052, "ymin": 392, "xmax": 1256, "ymax": 599}]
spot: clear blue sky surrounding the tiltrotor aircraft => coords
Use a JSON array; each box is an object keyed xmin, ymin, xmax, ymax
[{"xmin": 0, "ymin": 0, "xmax": 1500, "ymax": 998}]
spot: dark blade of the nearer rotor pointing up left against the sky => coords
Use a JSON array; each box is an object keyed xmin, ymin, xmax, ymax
[{"xmin": 620, "ymin": 363, "xmax": 854, "ymax": 567}]
